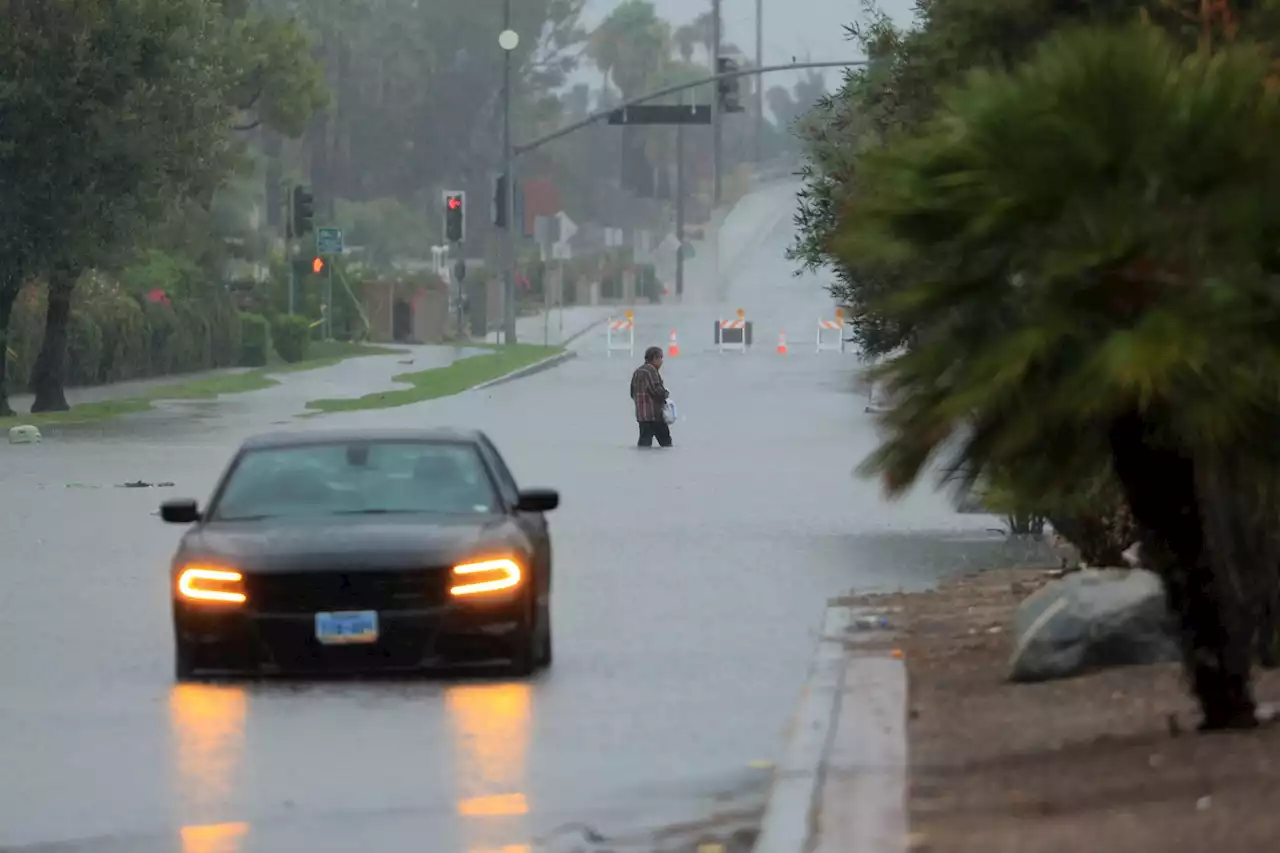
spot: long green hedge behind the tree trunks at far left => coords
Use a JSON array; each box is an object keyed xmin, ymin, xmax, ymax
[{"xmin": 6, "ymin": 277, "xmax": 241, "ymax": 391}]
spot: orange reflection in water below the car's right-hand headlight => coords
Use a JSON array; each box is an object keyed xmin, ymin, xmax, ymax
[{"xmin": 444, "ymin": 683, "xmax": 532, "ymax": 853}]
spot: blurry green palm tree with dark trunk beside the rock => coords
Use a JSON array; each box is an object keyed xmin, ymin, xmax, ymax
[{"xmin": 835, "ymin": 26, "xmax": 1280, "ymax": 729}]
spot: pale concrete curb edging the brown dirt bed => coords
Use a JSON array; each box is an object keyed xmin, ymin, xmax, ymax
[{"xmin": 754, "ymin": 605, "xmax": 909, "ymax": 853}]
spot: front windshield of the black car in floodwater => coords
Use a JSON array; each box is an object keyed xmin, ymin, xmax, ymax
[{"xmin": 211, "ymin": 442, "xmax": 497, "ymax": 521}]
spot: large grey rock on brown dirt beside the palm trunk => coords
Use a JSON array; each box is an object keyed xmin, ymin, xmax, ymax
[{"xmin": 1009, "ymin": 569, "xmax": 1179, "ymax": 681}]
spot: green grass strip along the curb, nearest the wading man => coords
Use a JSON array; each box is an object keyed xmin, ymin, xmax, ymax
[{"xmin": 307, "ymin": 343, "xmax": 564, "ymax": 412}]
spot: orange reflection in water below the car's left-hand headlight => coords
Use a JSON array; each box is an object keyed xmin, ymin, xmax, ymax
[{"xmin": 169, "ymin": 684, "xmax": 248, "ymax": 853}]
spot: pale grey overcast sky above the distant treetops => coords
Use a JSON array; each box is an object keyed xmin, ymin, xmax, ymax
[{"xmin": 585, "ymin": 0, "xmax": 914, "ymax": 88}]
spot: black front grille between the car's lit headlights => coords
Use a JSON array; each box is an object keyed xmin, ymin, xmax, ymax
[{"xmin": 246, "ymin": 569, "xmax": 449, "ymax": 613}]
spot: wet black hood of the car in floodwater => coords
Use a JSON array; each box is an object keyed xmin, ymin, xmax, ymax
[{"xmin": 178, "ymin": 515, "xmax": 529, "ymax": 573}]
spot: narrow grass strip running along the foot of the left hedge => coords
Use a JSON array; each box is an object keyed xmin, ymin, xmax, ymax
[{"xmin": 0, "ymin": 341, "xmax": 407, "ymax": 430}]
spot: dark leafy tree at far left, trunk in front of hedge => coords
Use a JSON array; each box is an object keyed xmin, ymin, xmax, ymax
[{"xmin": 0, "ymin": 0, "xmax": 244, "ymax": 411}]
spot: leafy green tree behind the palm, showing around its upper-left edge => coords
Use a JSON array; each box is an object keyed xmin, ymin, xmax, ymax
[{"xmin": 791, "ymin": 0, "xmax": 1280, "ymax": 356}]
